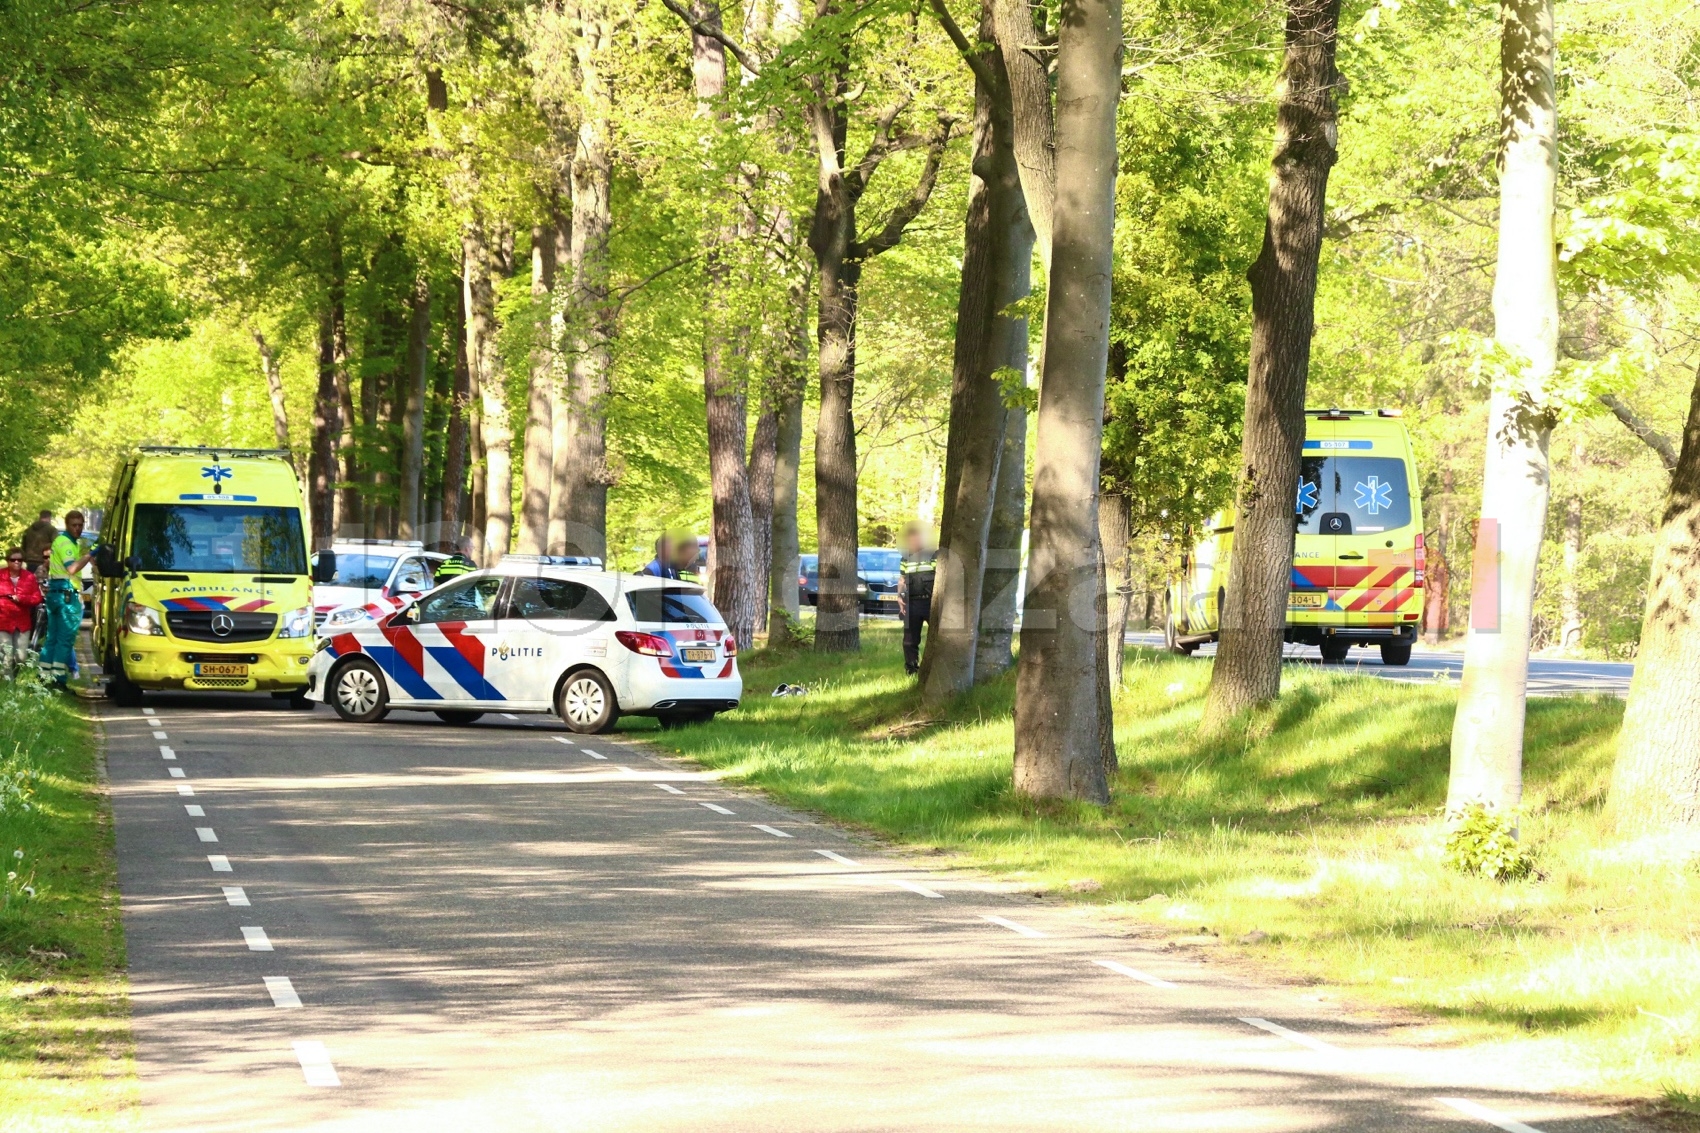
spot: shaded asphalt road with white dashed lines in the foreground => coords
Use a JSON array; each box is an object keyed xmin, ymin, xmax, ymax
[{"xmin": 104, "ymin": 696, "xmax": 1637, "ymax": 1133}]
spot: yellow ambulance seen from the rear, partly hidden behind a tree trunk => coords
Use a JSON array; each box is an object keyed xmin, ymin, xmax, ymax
[{"xmin": 1163, "ymin": 410, "xmax": 1426, "ymax": 665}]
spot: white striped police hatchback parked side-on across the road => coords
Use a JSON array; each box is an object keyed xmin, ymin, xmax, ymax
[{"xmin": 308, "ymin": 555, "xmax": 743, "ymax": 733}]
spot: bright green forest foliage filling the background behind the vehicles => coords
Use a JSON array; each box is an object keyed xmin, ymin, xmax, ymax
[{"xmin": 0, "ymin": 0, "xmax": 1700, "ymax": 657}]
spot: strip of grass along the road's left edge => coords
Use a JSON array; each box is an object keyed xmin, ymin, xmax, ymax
[{"xmin": 0, "ymin": 682, "xmax": 136, "ymax": 1133}]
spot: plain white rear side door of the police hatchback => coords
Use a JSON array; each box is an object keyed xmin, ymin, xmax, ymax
[{"xmin": 491, "ymin": 577, "xmax": 614, "ymax": 708}]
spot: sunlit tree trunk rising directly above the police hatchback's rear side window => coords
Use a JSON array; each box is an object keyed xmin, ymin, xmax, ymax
[{"xmin": 563, "ymin": 16, "xmax": 614, "ymax": 558}]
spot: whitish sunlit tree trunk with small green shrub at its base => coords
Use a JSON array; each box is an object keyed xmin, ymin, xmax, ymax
[{"xmin": 1447, "ymin": 0, "xmax": 1559, "ymax": 817}]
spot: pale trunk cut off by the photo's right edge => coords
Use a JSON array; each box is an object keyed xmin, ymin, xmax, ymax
[{"xmin": 1610, "ymin": 374, "xmax": 1700, "ymax": 835}]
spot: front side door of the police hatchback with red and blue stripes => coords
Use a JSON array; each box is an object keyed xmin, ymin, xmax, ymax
[{"xmin": 406, "ymin": 575, "xmax": 512, "ymax": 706}]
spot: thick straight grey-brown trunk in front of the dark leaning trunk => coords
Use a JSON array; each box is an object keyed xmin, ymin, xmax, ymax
[{"xmin": 1015, "ymin": 0, "xmax": 1122, "ymax": 803}]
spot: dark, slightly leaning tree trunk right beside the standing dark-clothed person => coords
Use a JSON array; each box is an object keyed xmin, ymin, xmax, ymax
[{"xmin": 923, "ymin": 28, "xmax": 1034, "ymax": 704}]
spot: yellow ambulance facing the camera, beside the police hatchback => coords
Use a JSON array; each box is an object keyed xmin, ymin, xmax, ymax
[{"xmin": 94, "ymin": 447, "xmax": 328, "ymax": 709}]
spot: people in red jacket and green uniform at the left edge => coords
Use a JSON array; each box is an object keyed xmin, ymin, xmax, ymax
[{"xmin": 0, "ymin": 510, "xmax": 94, "ymax": 689}]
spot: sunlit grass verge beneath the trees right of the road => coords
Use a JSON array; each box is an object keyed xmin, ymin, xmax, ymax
[{"xmin": 632, "ymin": 626, "xmax": 1700, "ymax": 1109}]
